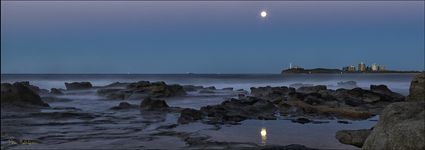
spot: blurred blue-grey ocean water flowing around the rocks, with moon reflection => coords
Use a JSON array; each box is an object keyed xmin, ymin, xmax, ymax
[{"xmin": 1, "ymin": 74, "xmax": 415, "ymax": 149}]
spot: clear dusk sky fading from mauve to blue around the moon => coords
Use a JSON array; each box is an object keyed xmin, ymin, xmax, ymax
[{"xmin": 1, "ymin": 1, "xmax": 425, "ymax": 73}]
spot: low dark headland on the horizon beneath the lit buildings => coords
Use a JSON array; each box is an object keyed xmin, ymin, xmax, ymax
[{"xmin": 281, "ymin": 68, "xmax": 421, "ymax": 74}]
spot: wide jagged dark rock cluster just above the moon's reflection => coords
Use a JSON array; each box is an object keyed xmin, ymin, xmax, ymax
[{"xmin": 251, "ymin": 85, "xmax": 405, "ymax": 119}]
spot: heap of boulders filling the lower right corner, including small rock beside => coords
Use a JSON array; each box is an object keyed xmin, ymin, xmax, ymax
[{"xmin": 336, "ymin": 73, "xmax": 425, "ymax": 150}]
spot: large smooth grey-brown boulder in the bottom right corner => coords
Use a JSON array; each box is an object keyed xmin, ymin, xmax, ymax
[{"xmin": 362, "ymin": 102, "xmax": 425, "ymax": 150}]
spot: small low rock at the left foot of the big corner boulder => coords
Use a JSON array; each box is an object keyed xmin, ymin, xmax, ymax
[{"xmin": 335, "ymin": 129, "xmax": 371, "ymax": 147}]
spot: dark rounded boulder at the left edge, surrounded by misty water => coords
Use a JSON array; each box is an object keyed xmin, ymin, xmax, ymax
[{"xmin": 1, "ymin": 82, "xmax": 49, "ymax": 107}]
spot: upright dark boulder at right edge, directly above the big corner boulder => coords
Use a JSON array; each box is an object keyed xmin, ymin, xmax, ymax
[{"xmin": 407, "ymin": 73, "xmax": 425, "ymax": 101}]
